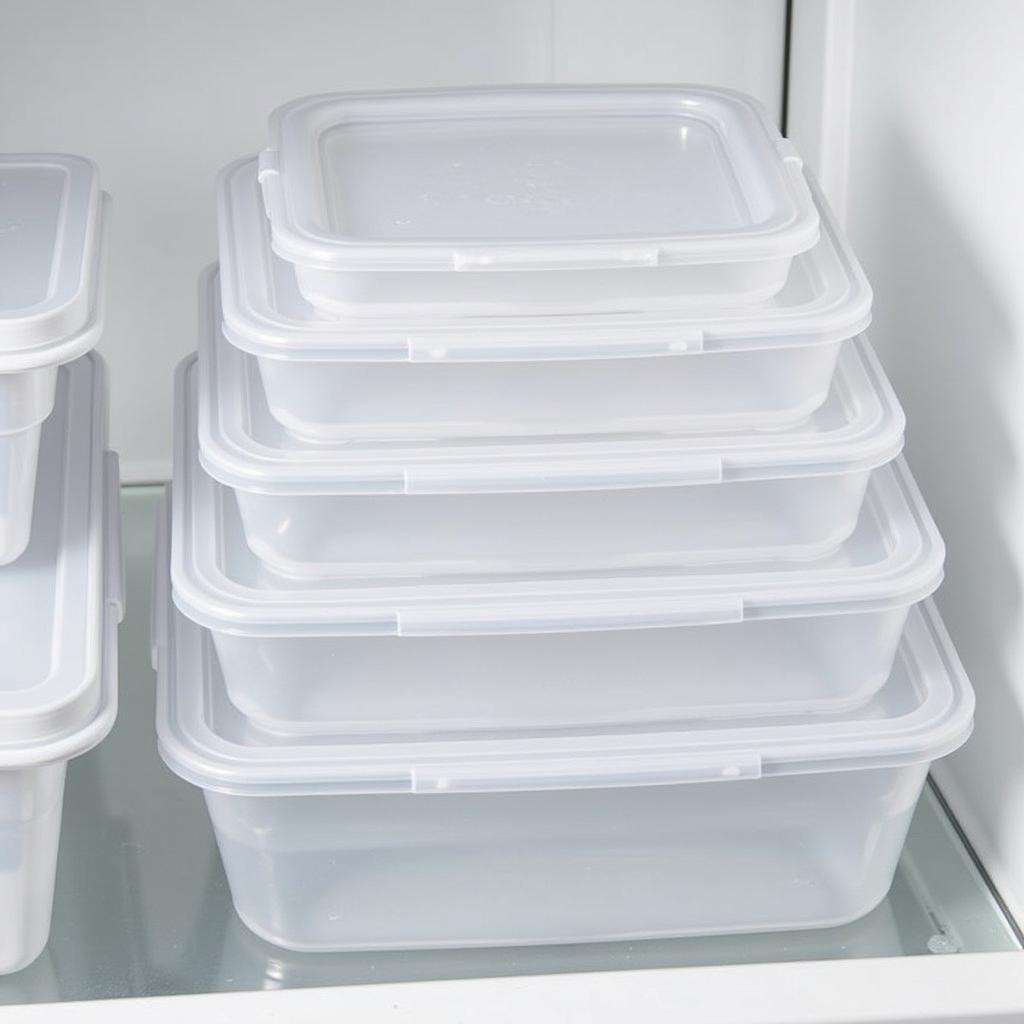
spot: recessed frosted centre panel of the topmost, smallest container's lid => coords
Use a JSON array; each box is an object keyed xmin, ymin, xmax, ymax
[{"xmin": 317, "ymin": 110, "xmax": 761, "ymax": 242}]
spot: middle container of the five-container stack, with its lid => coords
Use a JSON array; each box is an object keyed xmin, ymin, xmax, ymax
[{"xmin": 193, "ymin": 299, "xmax": 904, "ymax": 579}]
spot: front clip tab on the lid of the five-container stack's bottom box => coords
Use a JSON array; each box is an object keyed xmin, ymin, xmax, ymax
[{"xmin": 410, "ymin": 751, "xmax": 762, "ymax": 795}]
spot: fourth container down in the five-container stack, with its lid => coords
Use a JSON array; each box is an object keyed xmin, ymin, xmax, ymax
[{"xmin": 172, "ymin": 350, "xmax": 944, "ymax": 732}]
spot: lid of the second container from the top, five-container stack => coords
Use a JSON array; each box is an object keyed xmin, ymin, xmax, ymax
[{"xmin": 218, "ymin": 160, "xmax": 871, "ymax": 362}]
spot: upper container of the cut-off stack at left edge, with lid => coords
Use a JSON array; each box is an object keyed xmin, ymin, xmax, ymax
[{"xmin": 0, "ymin": 155, "xmax": 110, "ymax": 565}]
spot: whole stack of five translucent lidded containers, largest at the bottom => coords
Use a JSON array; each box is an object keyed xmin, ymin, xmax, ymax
[{"xmin": 154, "ymin": 87, "xmax": 973, "ymax": 950}]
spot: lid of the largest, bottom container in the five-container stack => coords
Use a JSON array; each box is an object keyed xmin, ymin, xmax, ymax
[{"xmin": 156, "ymin": 585, "xmax": 974, "ymax": 796}]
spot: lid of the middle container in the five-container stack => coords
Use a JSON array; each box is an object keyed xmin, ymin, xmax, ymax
[{"xmin": 198, "ymin": 271, "xmax": 904, "ymax": 495}]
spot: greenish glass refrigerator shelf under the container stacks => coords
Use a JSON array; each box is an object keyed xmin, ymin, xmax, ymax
[{"xmin": 0, "ymin": 488, "xmax": 1019, "ymax": 1004}]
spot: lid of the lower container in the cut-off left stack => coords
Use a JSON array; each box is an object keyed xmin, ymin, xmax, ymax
[{"xmin": 0, "ymin": 354, "xmax": 123, "ymax": 768}]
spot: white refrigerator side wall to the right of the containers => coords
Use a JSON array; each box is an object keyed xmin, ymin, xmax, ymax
[{"xmin": 790, "ymin": 0, "xmax": 1024, "ymax": 918}]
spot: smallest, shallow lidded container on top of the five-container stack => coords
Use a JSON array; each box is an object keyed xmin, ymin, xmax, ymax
[{"xmin": 260, "ymin": 86, "xmax": 818, "ymax": 316}]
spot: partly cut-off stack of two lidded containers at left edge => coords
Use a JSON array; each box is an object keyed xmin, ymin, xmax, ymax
[{"xmin": 0, "ymin": 155, "xmax": 123, "ymax": 974}]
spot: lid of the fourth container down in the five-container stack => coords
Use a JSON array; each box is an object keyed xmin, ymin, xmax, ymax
[{"xmin": 172, "ymin": 354, "xmax": 944, "ymax": 636}]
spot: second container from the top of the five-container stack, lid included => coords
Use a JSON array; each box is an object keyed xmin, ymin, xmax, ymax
[{"xmin": 220, "ymin": 160, "xmax": 871, "ymax": 441}]
